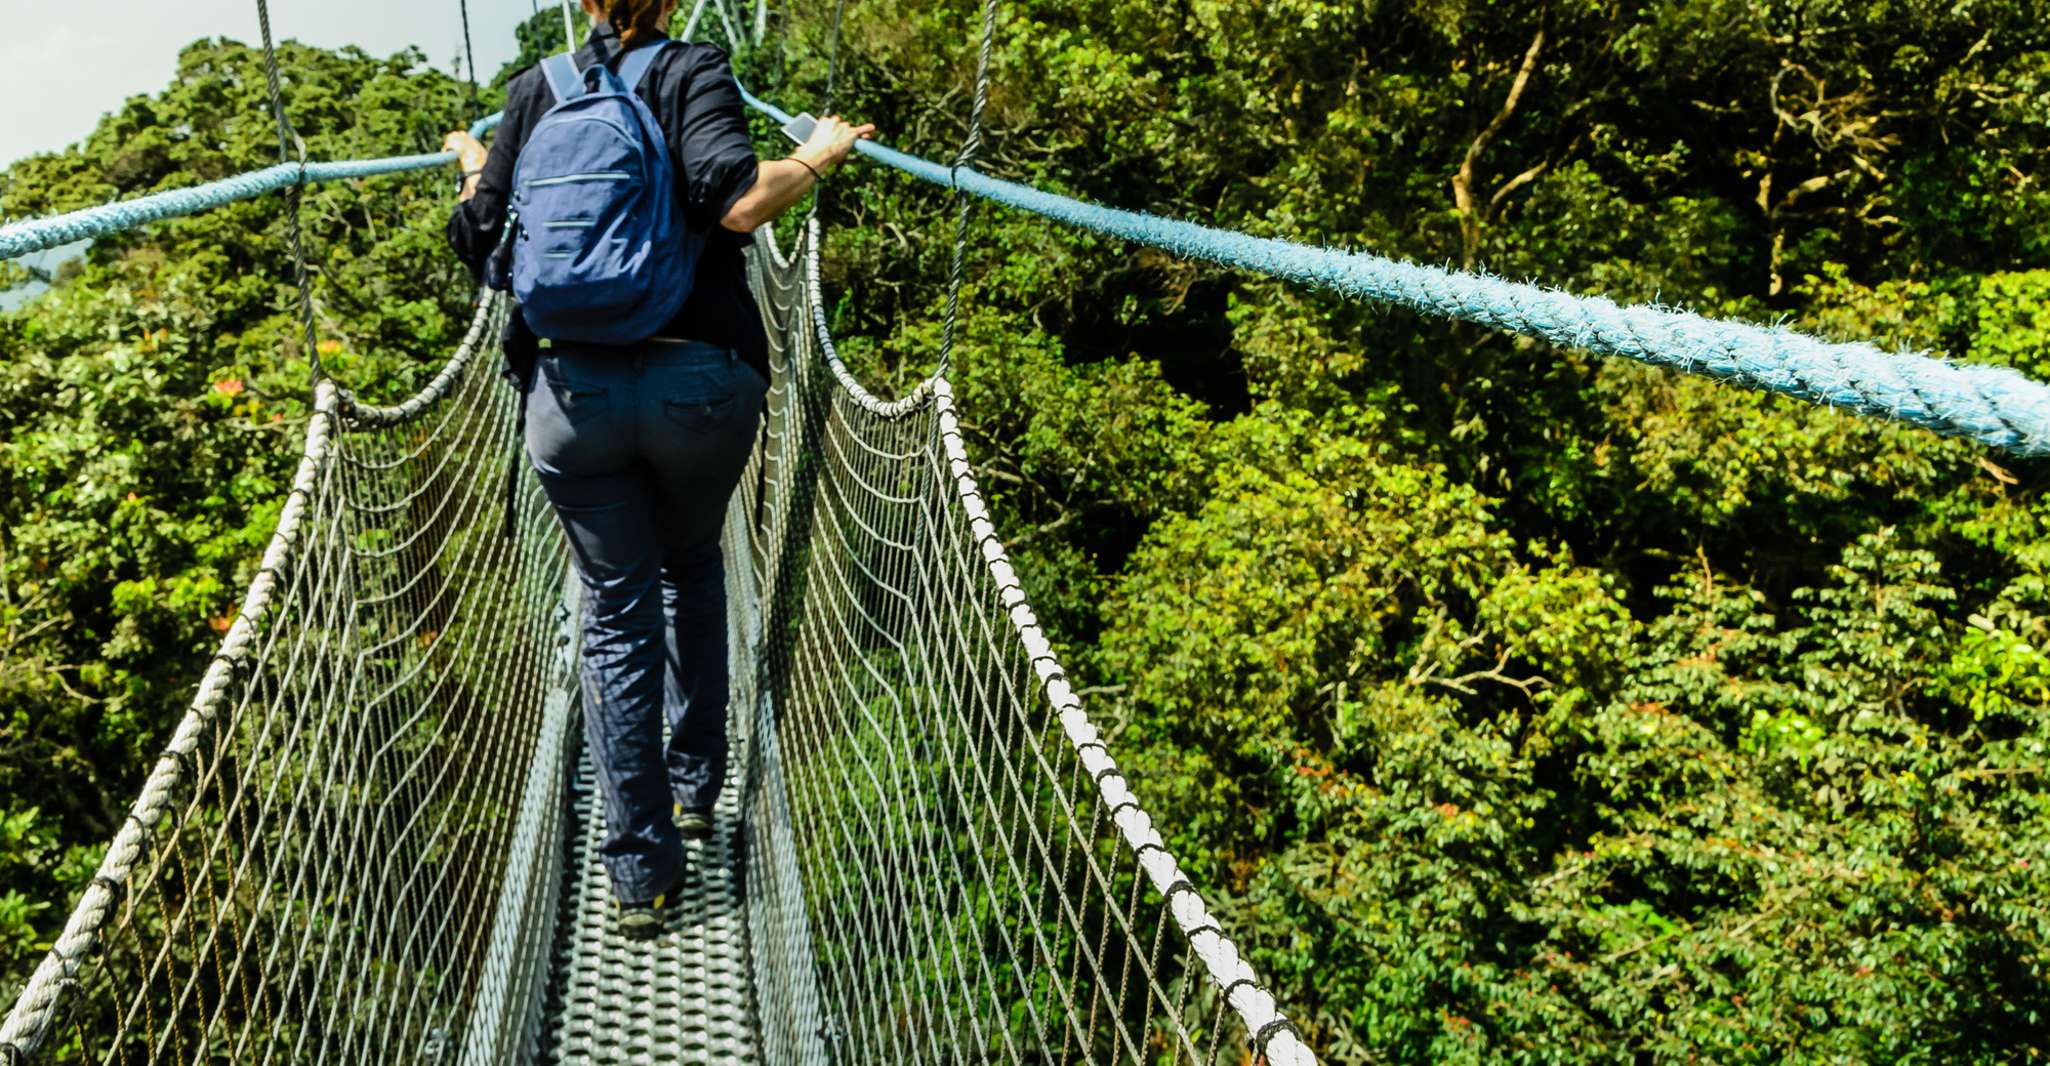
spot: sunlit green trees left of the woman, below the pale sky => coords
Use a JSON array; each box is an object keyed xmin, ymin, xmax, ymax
[{"xmin": 0, "ymin": 41, "xmax": 467, "ymax": 986}]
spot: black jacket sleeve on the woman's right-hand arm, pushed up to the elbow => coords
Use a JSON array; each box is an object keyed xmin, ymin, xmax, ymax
[{"xmin": 674, "ymin": 45, "xmax": 759, "ymax": 230}]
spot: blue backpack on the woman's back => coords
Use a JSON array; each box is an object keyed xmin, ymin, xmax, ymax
[{"xmin": 510, "ymin": 39, "xmax": 705, "ymax": 344}]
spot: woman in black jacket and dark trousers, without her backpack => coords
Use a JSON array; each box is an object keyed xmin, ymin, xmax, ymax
[{"xmin": 445, "ymin": 0, "xmax": 875, "ymax": 939}]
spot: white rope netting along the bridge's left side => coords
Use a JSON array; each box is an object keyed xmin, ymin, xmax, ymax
[{"xmin": 0, "ymin": 299, "xmax": 568, "ymax": 1062}]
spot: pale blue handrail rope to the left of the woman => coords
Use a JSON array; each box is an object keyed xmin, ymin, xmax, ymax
[{"xmin": 0, "ymin": 115, "xmax": 500, "ymax": 260}]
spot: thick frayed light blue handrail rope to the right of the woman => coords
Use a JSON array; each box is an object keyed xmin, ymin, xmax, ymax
[{"xmin": 740, "ymin": 88, "xmax": 2050, "ymax": 455}]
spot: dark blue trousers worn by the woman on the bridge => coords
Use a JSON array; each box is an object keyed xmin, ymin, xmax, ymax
[{"xmin": 527, "ymin": 340, "xmax": 769, "ymax": 902}]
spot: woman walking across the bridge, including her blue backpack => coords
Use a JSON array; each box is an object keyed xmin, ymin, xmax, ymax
[{"xmin": 447, "ymin": 0, "xmax": 873, "ymax": 939}]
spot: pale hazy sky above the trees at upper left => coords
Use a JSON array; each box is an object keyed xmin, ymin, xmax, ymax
[{"xmin": 0, "ymin": 0, "xmax": 539, "ymax": 166}]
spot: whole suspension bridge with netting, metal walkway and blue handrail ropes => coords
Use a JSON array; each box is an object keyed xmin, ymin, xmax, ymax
[{"xmin": 0, "ymin": 0, "xmax": 2050, "ymax": 1064}]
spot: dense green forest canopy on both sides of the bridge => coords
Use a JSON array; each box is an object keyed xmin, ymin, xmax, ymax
[{"xmin": 0, "ymin": 0, "xmax": 2050, "ymax": 1064}]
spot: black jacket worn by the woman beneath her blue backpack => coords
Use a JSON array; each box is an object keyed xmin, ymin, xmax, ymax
[{"xmin": 449, "ymin": 23, "xmax": 769, "ymax": 377}]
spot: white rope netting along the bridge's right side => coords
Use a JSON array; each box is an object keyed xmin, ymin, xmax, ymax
[{"xmin": 732, "ymin": 226, "xmax": 1314, "ymax": 1064}]
